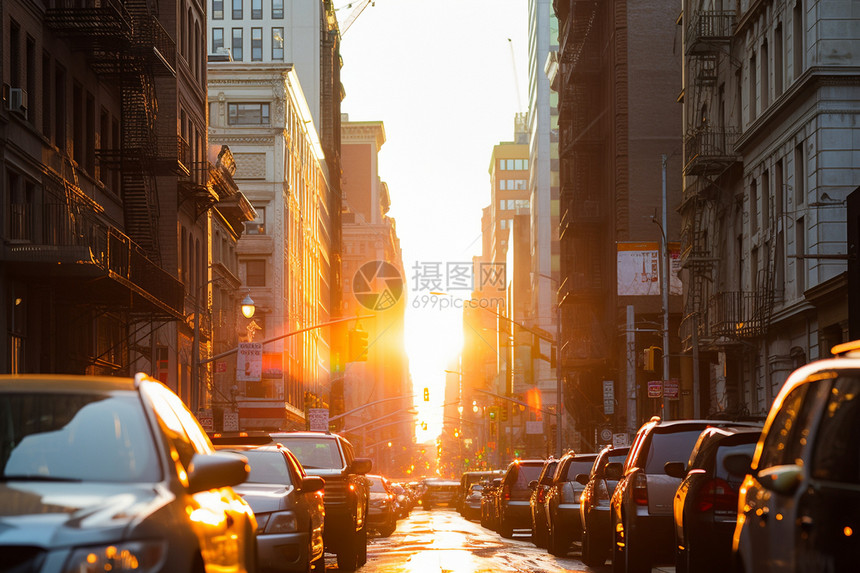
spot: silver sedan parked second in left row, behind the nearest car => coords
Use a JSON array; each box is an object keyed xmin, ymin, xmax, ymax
[{"xmin": 220, "ymin": 445, "xmax": 325, "ymax": 573}]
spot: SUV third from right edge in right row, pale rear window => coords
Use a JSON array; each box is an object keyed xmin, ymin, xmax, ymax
[{"xmin": 606, "ymin": 416, "xmax": 756, "ymax": 573}]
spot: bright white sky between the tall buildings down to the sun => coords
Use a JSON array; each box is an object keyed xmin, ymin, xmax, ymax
[{"xmin": 335, "ymin": 0, "xmax": 528, "ymax": 442}]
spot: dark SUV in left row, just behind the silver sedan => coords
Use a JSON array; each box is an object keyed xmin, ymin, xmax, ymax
[{"xmin": 270, "ymin": 432, "xmax": 372, "ymax": 571}]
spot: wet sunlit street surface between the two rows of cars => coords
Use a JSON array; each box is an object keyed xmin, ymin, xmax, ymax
[{"xmin": 326, "ymin": 509, "xmax": 674, "ymax": 573}]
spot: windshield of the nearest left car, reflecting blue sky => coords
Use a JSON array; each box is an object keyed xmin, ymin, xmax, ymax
[{"xmin": 0, "ymin": 392, "xmax": 161, "ymax": 482}]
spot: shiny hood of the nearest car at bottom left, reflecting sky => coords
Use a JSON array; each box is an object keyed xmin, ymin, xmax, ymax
[{"xmin": 0, "ymin": 481, "xmax": 175, "ymax": 548}]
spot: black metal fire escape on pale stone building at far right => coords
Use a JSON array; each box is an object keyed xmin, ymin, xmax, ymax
[{"xmin": 681, "ymin": 6, "xmax": 776, "ymax": 351}]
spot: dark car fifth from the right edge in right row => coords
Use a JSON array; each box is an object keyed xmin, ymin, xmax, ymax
[{"xmin": 544, "ymin": 452, "xmax": 597, "ymax": 556}]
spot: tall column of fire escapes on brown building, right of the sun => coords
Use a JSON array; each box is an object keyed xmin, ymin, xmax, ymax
[{"xmin": 556, "ymin": 1, "xmax": 611, "ymax": 435}]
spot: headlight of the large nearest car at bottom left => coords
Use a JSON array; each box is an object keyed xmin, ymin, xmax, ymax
[{"xmin": 63, "ymin": 540, "xmax": 167, "ymax": 573}]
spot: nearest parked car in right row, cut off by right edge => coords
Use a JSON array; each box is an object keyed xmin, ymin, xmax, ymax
[{"xmin": 727, "ymin": 341, "xmax": 860, "ymax": 573}]
